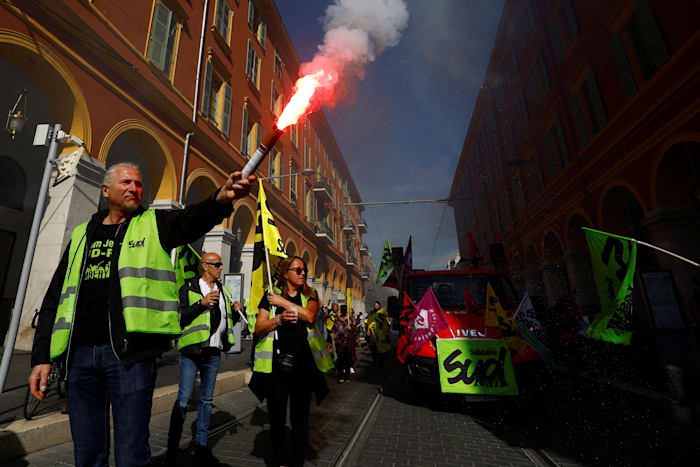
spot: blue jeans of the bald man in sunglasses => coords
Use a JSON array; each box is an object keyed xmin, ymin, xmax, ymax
[{"xmin": 168, "ymin": 349, "xmax": 221, "ymax": 450}]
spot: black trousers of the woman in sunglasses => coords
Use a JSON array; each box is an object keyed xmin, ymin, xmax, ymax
[{"xmin": 267, "ymin": 361, "xmax": 313, "ymax": 466}]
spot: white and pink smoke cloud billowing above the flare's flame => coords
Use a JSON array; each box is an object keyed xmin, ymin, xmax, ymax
[{"xmin": 300, "ymin": 0, "xmax": 409, "ymax": 107}]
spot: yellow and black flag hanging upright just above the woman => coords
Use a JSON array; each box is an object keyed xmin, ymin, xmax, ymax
[{"xmin": 246, "ymin": 181, "xmax": 287, "ymax": 332}]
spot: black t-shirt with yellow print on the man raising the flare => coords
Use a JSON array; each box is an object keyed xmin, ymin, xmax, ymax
[{"xmin": 71, "ymin": 224, "xmax": 122, "ymax": 345}]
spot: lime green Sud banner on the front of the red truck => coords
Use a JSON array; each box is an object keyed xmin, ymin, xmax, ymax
[{"xmin": 437, "ymin": 338, "xmax": 518, "ymax": 396}]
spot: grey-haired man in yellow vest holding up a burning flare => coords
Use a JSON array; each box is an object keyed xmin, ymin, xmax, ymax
[{"xmin": 29, "ymin": 163, "xmax": 256, "ymax": 466}]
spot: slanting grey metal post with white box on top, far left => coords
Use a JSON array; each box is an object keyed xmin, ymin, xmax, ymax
[{"xmin": 0, "ymin": 123, "xmax": 83, "ymax": 393}]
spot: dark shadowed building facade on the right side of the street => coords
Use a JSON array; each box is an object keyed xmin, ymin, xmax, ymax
[{"xmin": 451, "ymin": 0, "xmax": 700, "ymax": 388}]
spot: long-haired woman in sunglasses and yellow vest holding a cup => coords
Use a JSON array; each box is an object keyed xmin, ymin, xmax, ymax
[{"xmin": 248, "ymin": 256, "xmax": 333, "ymax": 465}]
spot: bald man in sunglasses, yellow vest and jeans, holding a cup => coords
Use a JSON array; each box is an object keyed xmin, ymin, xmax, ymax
[{"xmin": 166, "ymin": 253, "xmax": 241, "ymax": 466}]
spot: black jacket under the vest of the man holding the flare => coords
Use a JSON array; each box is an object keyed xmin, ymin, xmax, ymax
[{"xmin": 31, "ymin": 190, "xmax": 233, "ymax": 368}]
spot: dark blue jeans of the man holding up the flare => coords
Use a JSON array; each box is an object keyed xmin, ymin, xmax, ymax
[{"xmin": 68, "ymin": 345, "xmax": 156, "ymax": 467}]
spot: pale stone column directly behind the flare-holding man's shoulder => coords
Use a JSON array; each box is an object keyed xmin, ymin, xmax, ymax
[{"xmin": 15, "ymin": 154, "xmax": 105, "ymax": 350}]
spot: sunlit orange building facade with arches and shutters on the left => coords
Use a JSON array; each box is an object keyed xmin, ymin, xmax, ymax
[{"xmin": 0, "ymin": 0, "xmax": 366, "ymax": 349}]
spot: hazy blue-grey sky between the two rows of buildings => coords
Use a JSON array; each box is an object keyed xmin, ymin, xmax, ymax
[{"xmin": 275, "ymin": 0, "xmax": 504, "ymax": 269}]
